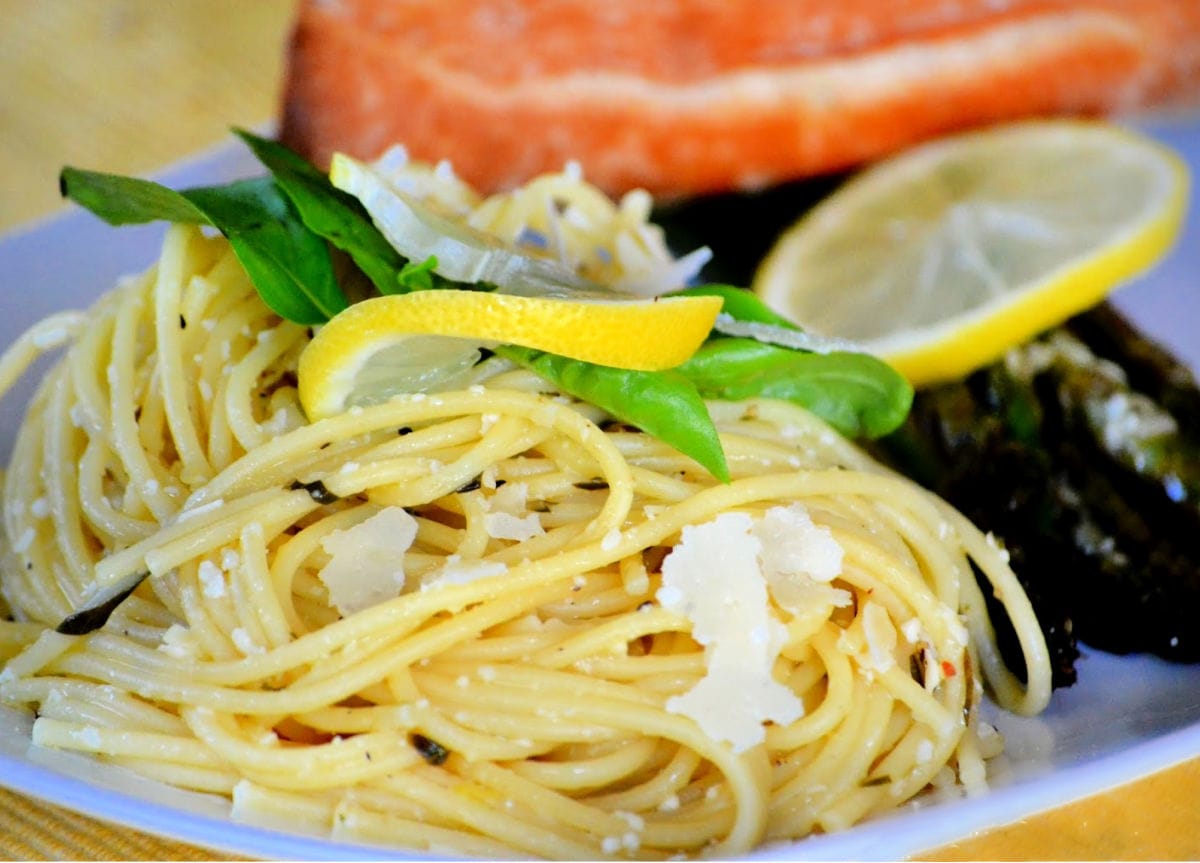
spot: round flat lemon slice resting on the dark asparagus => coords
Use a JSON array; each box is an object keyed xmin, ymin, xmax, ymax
[{"xmin": 754, "ymin": 120, "xmax": 1188, "ymax": 385}]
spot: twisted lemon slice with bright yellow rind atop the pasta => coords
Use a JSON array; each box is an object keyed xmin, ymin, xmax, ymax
[{"xmin": 298, "ymin": 290, "xmax": 721, "ymax": 420}]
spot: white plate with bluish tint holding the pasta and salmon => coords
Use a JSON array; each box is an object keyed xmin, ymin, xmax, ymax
[{"xmin": 0, "ymin": 118, "xmax": 1200, "ymax": 859}]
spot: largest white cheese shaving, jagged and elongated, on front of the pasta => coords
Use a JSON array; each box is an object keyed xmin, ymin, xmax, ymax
[{"xmin": 655, "ymin": 513, "xmax": 804, "ymax": 753}]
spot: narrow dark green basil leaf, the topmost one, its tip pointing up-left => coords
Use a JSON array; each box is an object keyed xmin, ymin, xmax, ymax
[{"xmin": 234, "ymin": 128, "xmax": 407, "ymax": 294}]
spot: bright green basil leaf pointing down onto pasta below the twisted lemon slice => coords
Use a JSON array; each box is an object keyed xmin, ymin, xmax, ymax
[{"xmin": 496, "ymin": 344, "xmax": 730, "ymax": 483}]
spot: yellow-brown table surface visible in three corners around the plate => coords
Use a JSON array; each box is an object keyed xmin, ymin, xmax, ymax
[{"xmin": 0, "ymin": 0, "xmax": 1200, "ymax": 861}]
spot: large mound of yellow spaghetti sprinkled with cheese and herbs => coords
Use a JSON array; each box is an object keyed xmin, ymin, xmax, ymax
[{"xmin": 0, "ymin": 190, "xmax": 1050, "ymax": 858}]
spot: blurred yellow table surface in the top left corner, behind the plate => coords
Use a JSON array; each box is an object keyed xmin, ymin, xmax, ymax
[{"xmin": 0, "ymin": 0, "xmax": 295, "ymax": 230}]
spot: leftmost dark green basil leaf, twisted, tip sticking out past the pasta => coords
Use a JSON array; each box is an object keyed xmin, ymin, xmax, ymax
[{"xmin": 59, "ymin": 168, "xmax": 347, "ymax": 324}]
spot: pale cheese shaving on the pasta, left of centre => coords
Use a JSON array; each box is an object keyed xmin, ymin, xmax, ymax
[{"xmin": 317, "ymin": 507, "xmax": 416, "ymax": 617}]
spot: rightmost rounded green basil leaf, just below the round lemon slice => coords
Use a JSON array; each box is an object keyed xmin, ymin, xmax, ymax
[{"xmin": 677, "ymin": 338, "xmax": 912, "ymax": 438}]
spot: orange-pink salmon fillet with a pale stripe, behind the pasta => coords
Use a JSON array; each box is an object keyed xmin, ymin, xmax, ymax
[{"xmin": 281, "ymin": 0, "xmax": 1200, "ymax": 197}]
